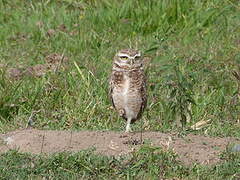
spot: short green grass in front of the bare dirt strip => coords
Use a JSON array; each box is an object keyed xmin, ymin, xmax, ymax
[{"xmin": 0, "ymin": 146, "xmax": 240, "ymax": 180}]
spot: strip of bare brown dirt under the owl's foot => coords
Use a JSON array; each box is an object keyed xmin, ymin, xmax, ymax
[{"xmin": 0, "ymin": 129, "xmax": 240, "ymax": 165}]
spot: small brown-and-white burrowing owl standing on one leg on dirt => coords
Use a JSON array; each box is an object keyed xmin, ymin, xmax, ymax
[{"xmin": 109, "ymin": 49, "xmax": 147, "ymax": 132}]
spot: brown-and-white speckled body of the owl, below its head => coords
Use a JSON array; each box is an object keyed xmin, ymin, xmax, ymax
[{"xmin": 110, "ymin": 70, "xmax": 147, "ymax": 123}]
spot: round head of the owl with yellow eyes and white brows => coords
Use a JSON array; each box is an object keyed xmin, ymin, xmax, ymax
[{"xmin": 114, "ymin": 49, "xmax": 143, "ymax": 69}]
